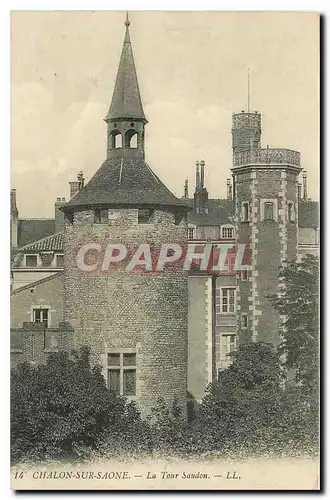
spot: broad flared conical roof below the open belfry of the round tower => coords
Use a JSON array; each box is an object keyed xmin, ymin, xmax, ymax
[{"xmin": 63, "ymin": 149, "xmax": 187, "ymax": 210}]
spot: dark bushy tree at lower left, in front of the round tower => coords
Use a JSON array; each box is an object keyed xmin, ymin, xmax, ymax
[{"xmin": 11, "ymin": 348, "xmax": 144, "ymax": 460}]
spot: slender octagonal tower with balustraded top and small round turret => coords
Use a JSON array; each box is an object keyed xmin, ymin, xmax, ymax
[{"xmin": 232, "ymin": 113, "xmax": 301, "ymax": 344}]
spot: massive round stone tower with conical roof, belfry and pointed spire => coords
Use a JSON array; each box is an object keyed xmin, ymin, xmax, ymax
[{"xmin": 63, "ymin": 16, "xmax": 188, "ymax": 414}]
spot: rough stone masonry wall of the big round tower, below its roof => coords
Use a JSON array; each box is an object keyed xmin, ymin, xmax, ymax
[{"xmin": 64, "ymin": 205, "xmax": 188, "ymax": 413}]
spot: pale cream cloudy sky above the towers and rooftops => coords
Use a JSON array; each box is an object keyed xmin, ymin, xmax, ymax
[{"xmin": 11, "ymin": 11, "xmax": 319, "ymax": 218}]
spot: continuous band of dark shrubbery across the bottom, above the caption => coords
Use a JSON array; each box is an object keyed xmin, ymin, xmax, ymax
[{"xmin": 11, "ymin": 342, "xmax": 318, "ymax": 461}]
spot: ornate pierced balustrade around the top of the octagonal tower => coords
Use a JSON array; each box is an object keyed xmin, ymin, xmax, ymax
[{"xmin": 233, "ymin": 146, "xmax": 300, "ymax": 167}]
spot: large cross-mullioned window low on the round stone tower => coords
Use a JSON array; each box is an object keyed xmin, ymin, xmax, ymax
[{"xmin": 107, "ymin": 352, "xmax": 136, "ymax": 396}]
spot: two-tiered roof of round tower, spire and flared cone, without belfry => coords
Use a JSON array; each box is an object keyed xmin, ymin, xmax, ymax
[{"xmin": 62, "ymin": 19, "xmax": 187, "ymax": 211}]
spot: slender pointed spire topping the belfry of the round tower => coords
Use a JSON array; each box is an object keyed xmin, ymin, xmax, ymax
[{"xmin": 105, "ymin": 12, "xmax": 147, "ymax": 123}]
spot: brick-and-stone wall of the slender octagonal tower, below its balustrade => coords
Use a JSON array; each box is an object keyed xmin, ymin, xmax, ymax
[{"xmin": 236, "ymin": 166, "xmax": 298, "ymax": 344}]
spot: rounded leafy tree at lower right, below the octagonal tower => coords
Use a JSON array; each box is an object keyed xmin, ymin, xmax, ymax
[{"xmin": 193, "ymin": 342, "xmax": 315, "ymax": 456}]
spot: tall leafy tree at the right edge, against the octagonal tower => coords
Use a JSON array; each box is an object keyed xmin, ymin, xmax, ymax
[{"xmin": 270, "ymin": 255, "xmax": 319, "ymax": 391}]
